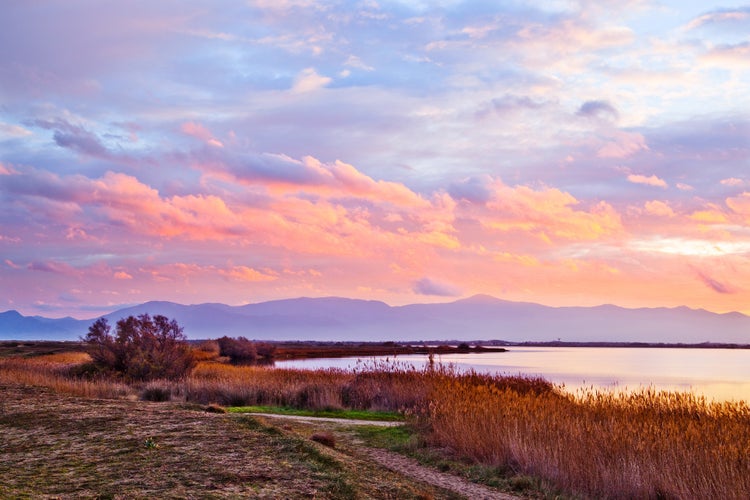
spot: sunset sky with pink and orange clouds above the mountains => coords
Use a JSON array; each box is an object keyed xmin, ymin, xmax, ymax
[{"xmin": 0, "ymin": 0, "xmax": 750, "ymax": 318}]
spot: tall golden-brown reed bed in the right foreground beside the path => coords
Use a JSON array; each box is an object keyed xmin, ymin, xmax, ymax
[{"xmin": 420, "ymin": 377, "xmax": 750, "ymax": 498}]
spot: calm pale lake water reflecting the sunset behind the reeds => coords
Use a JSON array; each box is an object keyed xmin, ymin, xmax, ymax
[{"xmin": 276, "ymin": 347, "xmax": 750, "ymax": 401}]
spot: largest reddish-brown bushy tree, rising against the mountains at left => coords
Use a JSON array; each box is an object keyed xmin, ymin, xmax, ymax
[{"xmin": 83, "ymin": 314, "xmax": 195, "ymax": 380}]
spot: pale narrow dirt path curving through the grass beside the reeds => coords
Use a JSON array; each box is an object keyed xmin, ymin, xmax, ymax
[{"xmin": 254, "ymin": 413, "xmax": 521, "ymax": 500}]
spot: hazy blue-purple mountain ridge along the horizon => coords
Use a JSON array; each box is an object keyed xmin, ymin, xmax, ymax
[{"xmin": 0, "ymin": 295, "xmax": 750, "ymax": 344}]
